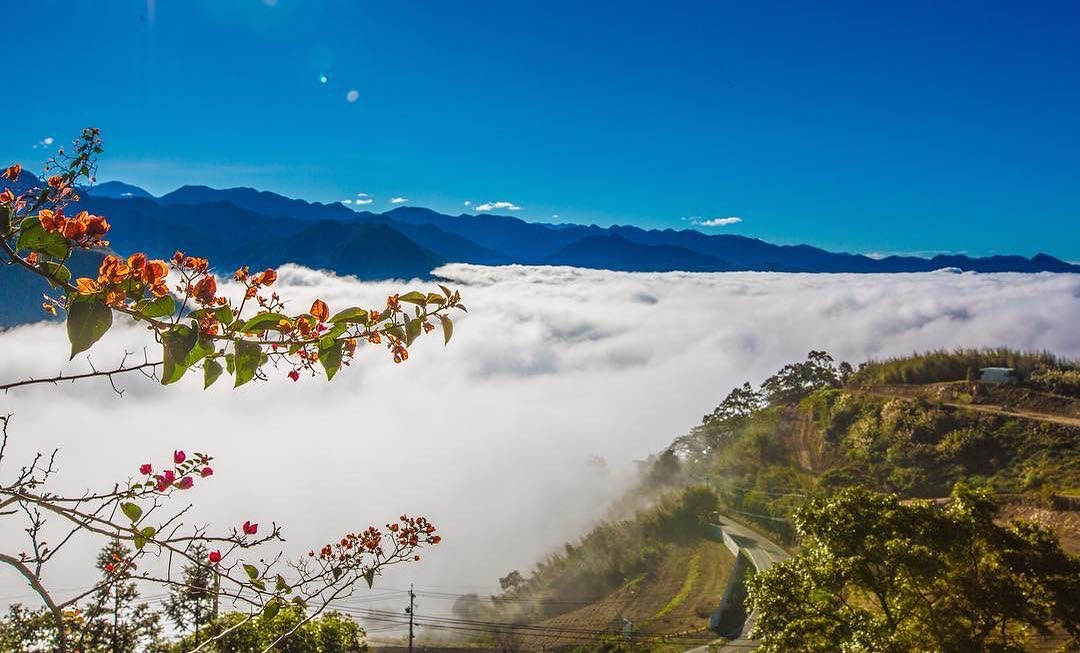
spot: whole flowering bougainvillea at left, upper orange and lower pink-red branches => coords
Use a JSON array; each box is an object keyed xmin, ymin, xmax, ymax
[{"xmin": 0, "ymin": 128, "xmax": 465, "ymax": 653}]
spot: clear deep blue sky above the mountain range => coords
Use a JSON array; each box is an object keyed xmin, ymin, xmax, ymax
[{"xmin": 0, "ymin": 0, "xmax": 1080, "ymax": 260}]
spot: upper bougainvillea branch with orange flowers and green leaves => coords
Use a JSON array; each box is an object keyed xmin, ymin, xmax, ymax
[{"xmin": 0, "ymin": 128, "xmax": 465, "ymax": 387}]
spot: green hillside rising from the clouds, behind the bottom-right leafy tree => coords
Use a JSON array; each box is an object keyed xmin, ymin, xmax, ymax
[{"xmin": 481, "ymin": 350, "xmax": 1080, "ymax": 651}]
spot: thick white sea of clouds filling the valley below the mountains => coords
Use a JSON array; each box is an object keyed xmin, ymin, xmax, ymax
[{"xmin": 0, "ymin": 264, "xmax": 1080, "ymax": 621}]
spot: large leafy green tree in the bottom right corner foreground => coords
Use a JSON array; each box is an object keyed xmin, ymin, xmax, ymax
[{"xmin": 748, "ymin": 485, "xmax": 1080, "ymax": 653}]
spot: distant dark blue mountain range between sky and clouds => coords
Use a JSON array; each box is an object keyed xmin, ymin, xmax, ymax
[{"xmin": 0, "ymin": 173, "xmax": 1080, "ymax": 326}]
